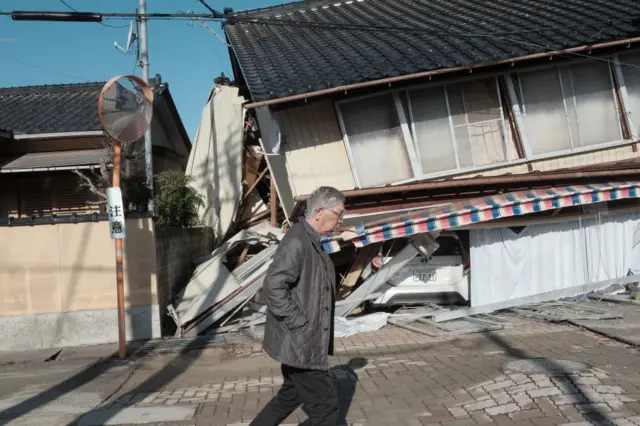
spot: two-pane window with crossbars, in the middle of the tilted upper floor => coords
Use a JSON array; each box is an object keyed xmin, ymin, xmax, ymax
[{"xmin": 409, "ymin": 79, "xmax": 515, "ymax": 174}]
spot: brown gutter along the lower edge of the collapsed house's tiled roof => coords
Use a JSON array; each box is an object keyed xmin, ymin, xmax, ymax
[{"xmin": 244, "ymin": 37, "xmax": 640, "ymax": 109}]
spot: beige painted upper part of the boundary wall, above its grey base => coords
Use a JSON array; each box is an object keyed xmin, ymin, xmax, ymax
[{"xmin": 0, "ymin": 218, "xmax": 157, "ymax": 316}]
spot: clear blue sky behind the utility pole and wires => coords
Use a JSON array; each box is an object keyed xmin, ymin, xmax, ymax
[{"xmin": 0, "ymin": 0, "xmax": 288, "ymax": 141}]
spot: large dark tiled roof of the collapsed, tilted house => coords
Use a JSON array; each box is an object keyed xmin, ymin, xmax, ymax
[{"xmin": 225, "ymin": 0, "xmax": 640, "ymax": 101}]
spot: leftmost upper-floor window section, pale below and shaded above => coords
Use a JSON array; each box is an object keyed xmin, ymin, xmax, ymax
[{"xmin": 340, "ymin": 94, "xmax": 413, "ymax": 187}]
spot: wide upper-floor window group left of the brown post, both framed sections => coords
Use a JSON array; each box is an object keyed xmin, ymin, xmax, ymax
[{"xmin": 338, "ymin": 78, "xmax": 516, "ymax": 187}]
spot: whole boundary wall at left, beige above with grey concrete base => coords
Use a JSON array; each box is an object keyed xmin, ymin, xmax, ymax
[{"xmin": 0, "ymin": 218, "xmax": 160, "ymax": 350}]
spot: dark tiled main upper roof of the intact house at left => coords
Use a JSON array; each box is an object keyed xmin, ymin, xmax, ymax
[{"xmin": 0, "ymin": 76, "xmax": 166, "ymax": 135}]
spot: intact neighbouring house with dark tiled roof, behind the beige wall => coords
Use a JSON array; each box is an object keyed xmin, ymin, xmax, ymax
[{"xmin": 0, "ymin": 74, "xmax": 191, "ymax": 218}]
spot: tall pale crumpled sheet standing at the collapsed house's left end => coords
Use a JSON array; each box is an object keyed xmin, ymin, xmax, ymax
[{"xmin": 185, "ymin": 86, "xmax": 244, "ymax": 241}]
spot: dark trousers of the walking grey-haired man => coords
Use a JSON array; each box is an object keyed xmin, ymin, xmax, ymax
[{"xmin": 250, "ymin": 365, "xmax": 339, "ymax": 426}]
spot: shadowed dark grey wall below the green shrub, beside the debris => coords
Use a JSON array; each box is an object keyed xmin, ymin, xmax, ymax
[{"xmin": 156, "ymin": 228, "xmax": 214, "ymax": 335}]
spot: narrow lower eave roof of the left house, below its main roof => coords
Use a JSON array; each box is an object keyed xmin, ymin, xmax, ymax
[{"xmin": 0, "ymin": 149, "xmax": 103, "ymax": 173}]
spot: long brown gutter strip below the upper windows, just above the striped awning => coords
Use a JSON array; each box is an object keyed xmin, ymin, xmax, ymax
[{"xmin": 294, "ymin": 164, "xmax": 640, "ymax": 202}]
